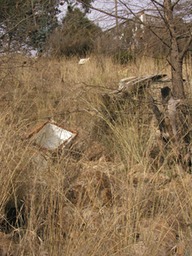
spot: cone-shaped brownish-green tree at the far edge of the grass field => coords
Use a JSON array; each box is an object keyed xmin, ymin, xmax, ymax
[{"xmin": 50, "ymin": 8, "xmax": 101, "ymax": 56}]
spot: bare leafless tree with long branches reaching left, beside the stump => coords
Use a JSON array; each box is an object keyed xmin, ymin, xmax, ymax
[{"xmin": 85, "ymin": 0, "xmax": 192, "ymax": 99}]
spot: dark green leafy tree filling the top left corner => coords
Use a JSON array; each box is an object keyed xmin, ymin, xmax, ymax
[{"xmin": 0, "ymin": 0, "xmax": 59, "ymax": 51}]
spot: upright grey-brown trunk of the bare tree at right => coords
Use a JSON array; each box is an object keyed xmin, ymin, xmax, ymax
[{"xmin": 157, "ymin": 0, "xmax": 192, "ymax": 99}]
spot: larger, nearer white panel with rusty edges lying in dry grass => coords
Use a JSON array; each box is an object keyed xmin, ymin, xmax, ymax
[{"xmin": 33, "ymin": 123, "xmax": 75, "ymax": 150}]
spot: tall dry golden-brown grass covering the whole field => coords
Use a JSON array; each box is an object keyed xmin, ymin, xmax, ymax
[{"xmin": 0, "ymin": 53, "xmax": 192, "ymax": 256}]
